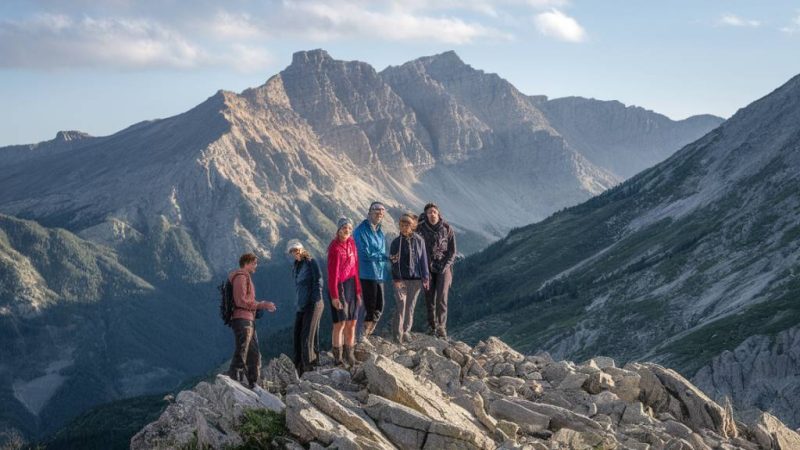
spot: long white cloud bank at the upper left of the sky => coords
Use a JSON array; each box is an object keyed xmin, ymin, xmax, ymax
[{"xmin": 0, "ymin": 14, "xmax": 208, "ymax": 68}]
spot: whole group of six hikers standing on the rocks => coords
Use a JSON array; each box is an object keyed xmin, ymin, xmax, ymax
[{"xmin": 228, "ymin": 201, "xmax": 456, "ymax": 387}]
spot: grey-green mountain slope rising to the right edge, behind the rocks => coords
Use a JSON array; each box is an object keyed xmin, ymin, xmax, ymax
[{"xmin": 452, "ymin": 77, "xmax": 800, "ymax": 426}]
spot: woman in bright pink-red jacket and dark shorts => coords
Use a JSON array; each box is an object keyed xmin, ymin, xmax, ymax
[{"xmin": 328, "ymin": 217, "xmax": 361, "ymax": 366}]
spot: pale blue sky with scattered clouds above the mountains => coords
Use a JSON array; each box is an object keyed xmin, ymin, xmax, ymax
[{"xmin": 0, "ymin": 0, "xmax": 800, "ymax": 146}]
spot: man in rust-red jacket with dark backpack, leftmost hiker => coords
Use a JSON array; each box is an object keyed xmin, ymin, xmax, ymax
[{"xmin": 228, "ymin": 253, "xmax": 275, "ymax": 389}]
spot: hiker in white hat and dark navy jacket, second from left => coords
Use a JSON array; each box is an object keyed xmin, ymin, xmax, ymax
[{"xmin": 287, "ymin": 239, "xmax": 325, "ymax": 376}]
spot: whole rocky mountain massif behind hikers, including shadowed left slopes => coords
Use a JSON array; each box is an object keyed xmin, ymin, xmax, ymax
[{"xmin": 0, "ymin": 50, "xmax": 720, "ymax": 440}]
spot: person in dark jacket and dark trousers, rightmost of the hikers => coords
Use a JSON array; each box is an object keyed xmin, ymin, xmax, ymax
[{"xmin": 418, "ymin": 203, "xmax": 456, "ymax": 338}]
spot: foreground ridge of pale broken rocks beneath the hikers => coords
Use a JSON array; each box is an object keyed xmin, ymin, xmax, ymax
[{"xmin": 131, "ymin": 334, "xmax": 800, "ymax": 450}]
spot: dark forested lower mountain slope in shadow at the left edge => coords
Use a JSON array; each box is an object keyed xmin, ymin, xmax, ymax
[{"xmin": 0, "ymin": 216, "xmax": 229, "ymax": 440}]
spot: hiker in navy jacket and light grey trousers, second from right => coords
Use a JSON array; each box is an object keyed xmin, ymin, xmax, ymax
[{"xmin": 389, "ymin": 214, "xmax": 430, "ymax": 344}]
